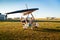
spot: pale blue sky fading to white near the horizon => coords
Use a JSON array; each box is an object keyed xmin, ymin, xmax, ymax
[{"xmin": 0, "ymin": 0, "xmax": 60, "ymax": 18}]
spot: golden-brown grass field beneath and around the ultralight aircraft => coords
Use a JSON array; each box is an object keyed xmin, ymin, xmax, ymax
[{"xmin": 0, "ymin": 22, "xmax": 60, "ymax": 40}]
